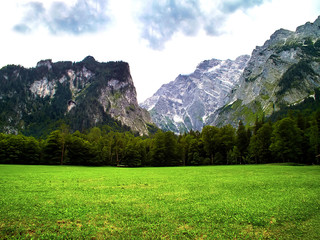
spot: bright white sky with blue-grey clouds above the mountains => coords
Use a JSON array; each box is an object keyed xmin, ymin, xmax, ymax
[{"xmin": 0, "ymin": 0, "xmax": 320, "ymax": 102}]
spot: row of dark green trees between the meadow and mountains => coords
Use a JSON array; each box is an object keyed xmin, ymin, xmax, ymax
[{"xmin": 0, "ymin": 111, "xmax": 320, "ymax": 167}]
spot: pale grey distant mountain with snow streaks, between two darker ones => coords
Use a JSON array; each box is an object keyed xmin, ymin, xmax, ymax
[{"xmin": 140, "ymin": 55, "xmax": 249, "ymax": 133}]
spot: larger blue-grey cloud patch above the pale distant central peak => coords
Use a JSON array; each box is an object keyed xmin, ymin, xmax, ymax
[{"xmin": 139, "ymin": 0, "xmax": 268, "ymax": 50}]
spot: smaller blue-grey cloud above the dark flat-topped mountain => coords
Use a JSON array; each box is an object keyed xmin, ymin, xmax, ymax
[{"xmin": 13, "ymin": 0, "xmax": 111, "ymax": 35}]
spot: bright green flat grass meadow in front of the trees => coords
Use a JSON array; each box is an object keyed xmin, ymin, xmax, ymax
[{"xmin": 0, "ymin": 165, "xmax": 320, "ymax": 240}]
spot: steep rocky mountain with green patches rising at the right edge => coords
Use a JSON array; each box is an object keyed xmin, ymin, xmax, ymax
[{"xmin": 211, "ymin": 17, "xmax": 320, "ymax": 125}]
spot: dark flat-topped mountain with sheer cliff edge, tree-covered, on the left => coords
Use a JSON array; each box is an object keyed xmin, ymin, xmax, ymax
[{"xmin": 0, "ymin": 56, "xmax": 152, "ymax": 136}]
